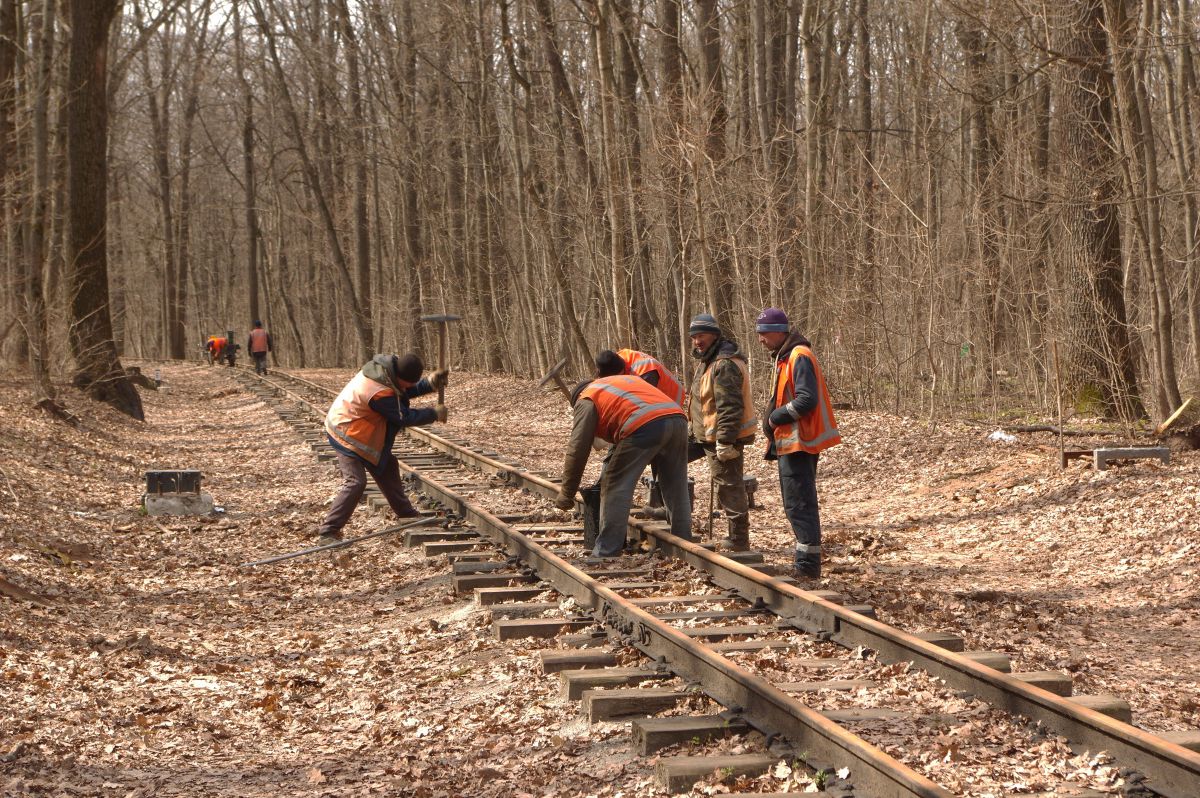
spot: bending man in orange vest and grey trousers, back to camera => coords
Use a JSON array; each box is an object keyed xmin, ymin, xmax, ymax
[{"xmin": 554, "ymin": 374, "xmax": 691, "ymax": 557}]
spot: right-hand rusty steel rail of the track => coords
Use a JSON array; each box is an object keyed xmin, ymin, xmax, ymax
[{"xmin": 241, "ymin": 364, "xmax": 1200, "ymax": 798}]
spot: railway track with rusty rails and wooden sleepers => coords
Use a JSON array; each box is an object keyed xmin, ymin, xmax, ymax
[{"xmin": 226, "ymin": 370, "xmax": 1200, "ymax": 798}]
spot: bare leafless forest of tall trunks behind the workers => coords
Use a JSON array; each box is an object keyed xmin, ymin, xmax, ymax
[{"xmin": 0, "ymin": 0, "xmax": 1200, "ymax": 421}]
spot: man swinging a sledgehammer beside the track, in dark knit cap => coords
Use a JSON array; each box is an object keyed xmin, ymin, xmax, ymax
[{"xmin": 318, "ymin": 353, "xmax": 449, "ymax": 545}]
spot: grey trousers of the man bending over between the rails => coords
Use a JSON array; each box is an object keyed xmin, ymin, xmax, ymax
[{"xmin": 593, "ymin": 415, "xmax": 691, "ymax": 557}]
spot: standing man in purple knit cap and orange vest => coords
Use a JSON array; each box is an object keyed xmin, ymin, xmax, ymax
[{"xmin": 755, "ymin": 307, "xmax": 841, "ymax": 578}]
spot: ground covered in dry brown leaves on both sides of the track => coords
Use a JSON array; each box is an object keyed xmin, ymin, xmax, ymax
[{"xmin": 0, "ymin": 365, "xmax": 1200, "ymax": 796}]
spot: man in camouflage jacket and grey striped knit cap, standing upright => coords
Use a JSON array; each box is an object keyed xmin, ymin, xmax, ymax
[{"xmin": 688, "ymin": 313, "xmax": 758, "ymax": 551}]
